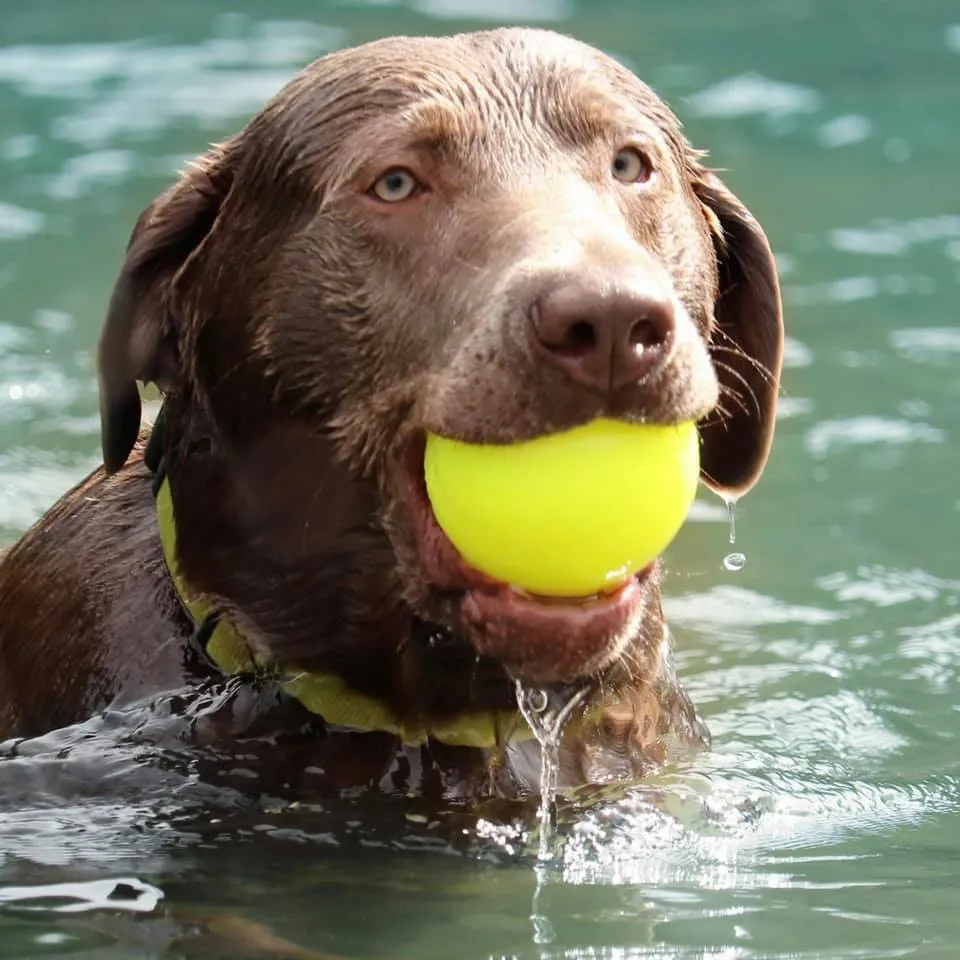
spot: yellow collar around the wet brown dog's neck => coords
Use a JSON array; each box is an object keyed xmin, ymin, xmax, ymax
[{"xmin": 157, "ymin": 477, "xmax": 533, "ymax": 748}]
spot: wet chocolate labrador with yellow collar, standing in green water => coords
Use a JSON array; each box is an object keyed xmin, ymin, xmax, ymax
[{"xmin": 0, "ymin": 29, "xmax": 782, "ymax": 796}]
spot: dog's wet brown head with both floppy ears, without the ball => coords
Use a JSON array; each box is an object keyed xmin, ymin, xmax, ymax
[{"xmin": 100, "ymin": 29, "xmax": 782, "ymax": 680}]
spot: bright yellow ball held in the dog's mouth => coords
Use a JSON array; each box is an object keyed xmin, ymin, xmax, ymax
[{"xmin": 424, "ymin": 420, "xmax": 700, "ymax": 597}]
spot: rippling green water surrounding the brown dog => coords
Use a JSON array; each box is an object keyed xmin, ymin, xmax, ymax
[{"xmin": 0, "ymin": 0, "xmax": 960, "ymax": 960}]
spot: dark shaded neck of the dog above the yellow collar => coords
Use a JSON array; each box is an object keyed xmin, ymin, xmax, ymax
[{"xmin": 148, "ymin": 405, "xmax": 515, "ymax": 721}]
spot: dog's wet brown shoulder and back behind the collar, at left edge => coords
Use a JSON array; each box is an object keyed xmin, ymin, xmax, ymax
[{"xmin": 0, "ymin": 451, "xmax": 189, "ymax": 738}]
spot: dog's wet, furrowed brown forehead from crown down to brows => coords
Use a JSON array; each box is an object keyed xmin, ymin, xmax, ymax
[{"xmin": 242, "ymin": 28, "xmax": 684, "ymax": 190}]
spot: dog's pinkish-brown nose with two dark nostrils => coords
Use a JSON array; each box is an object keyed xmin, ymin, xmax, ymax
[{"xmin": 530, "ymin": 280, "xmax": 676, "ymax": 393}]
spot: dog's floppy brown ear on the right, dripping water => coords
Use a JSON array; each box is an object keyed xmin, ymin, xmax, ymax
[{"xmin": 694, "ymin": 171, "xmax": 783, "ymax": 495}]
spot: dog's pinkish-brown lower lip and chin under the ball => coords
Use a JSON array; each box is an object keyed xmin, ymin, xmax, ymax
[{"xmin": 401, "ymin": 437, "xmax": 656, "ymax": 684}]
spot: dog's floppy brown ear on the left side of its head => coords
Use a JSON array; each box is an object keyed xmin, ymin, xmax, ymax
[{"xmin": 98, "ymin": 149, "xmax": 229, "ymax": 473}]
